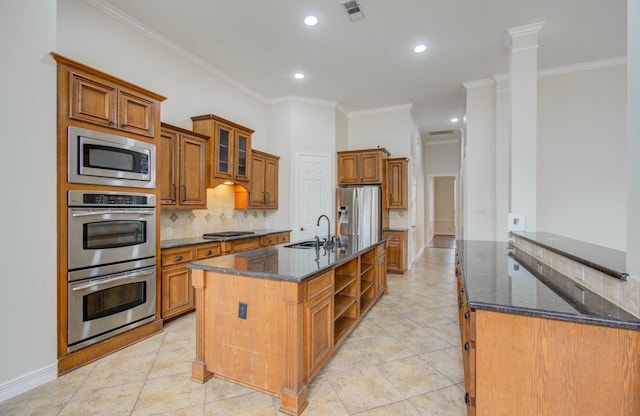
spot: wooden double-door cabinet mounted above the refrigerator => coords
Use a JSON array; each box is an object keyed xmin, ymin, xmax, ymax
[{"xmin": 338, "ymin": 148, "xmax": 389, "ymax": 185}]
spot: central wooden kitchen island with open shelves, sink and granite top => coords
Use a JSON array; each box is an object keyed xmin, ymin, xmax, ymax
[{"xmin": 188, "ymin": 239, "xmax": 387, "ymax": 415}]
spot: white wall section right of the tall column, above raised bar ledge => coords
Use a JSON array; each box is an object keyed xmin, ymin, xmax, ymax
[{"xmin": 537, "ymin": 65, "xmax": 627, "ymax": 251}]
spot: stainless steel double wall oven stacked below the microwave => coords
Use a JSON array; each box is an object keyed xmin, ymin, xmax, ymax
[{"xmin": 67, "ymin": 190, "xmax": 156, "ymax": 351}]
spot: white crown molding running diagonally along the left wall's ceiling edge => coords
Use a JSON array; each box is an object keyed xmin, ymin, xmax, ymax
[{"xmin": 85, "ymin": 0, "xmax": 267, "ymax": 104}]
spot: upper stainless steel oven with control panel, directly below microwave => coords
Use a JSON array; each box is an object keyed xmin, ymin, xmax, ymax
[{"xmin": 68, "ymin": 190, "xmax": 156, "ymax": 270}]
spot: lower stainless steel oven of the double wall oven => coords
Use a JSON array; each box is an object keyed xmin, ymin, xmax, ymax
[{"xmin": 67, "ymin": 258, "xmax": 156, "ymax": 351}]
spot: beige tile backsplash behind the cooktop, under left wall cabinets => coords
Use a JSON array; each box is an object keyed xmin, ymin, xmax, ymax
[{"xmin": 160, "ymin": 185, "xmax": 272, "ymax": 240}]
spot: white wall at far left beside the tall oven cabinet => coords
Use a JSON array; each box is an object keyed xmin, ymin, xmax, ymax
[{"xmin": 0, "ymin": 0, "xmax": 57, "ymax": 401}]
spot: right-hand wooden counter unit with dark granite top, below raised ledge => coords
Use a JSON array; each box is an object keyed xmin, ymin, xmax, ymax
[{"xmin": 456, "ymin": 241, "xmax": 640, "ymax": 416}]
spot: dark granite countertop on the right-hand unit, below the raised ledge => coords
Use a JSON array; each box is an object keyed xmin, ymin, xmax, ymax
[{"xmin": 456, "ymin": 240, "xmax": 640, "ymax": 330}]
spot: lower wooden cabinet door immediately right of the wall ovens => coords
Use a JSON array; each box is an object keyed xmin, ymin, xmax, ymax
[{"xmin": 162, "ymin": 266, "xmax": 195, "ymax": 319}]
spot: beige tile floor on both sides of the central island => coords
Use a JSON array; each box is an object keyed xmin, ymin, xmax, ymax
[{"xmin": 0, "ymin": 248, "xmax": 466, "ymax": 416}]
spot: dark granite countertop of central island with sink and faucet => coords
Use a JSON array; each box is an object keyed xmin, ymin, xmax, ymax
[{"xmin": 187, "ymin": 237, "xmax": 384, "ymax": 282}]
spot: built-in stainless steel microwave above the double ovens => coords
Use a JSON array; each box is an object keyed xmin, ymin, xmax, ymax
[{"xmin": 67, "ymin": 126, "xmax": 156, "ymax": 188}]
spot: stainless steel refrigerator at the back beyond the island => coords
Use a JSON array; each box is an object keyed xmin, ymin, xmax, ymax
[{"xmin": 336, "ymin": 185, "xmax": 382, "ymax": 247}]
